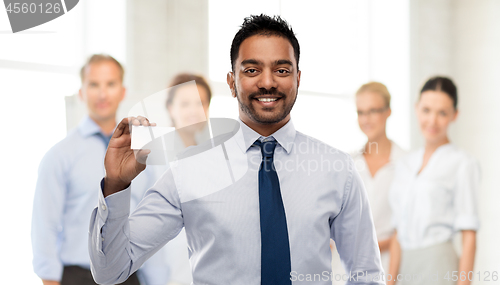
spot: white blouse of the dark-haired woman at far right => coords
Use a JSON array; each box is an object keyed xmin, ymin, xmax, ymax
[{"xmin": 390, "ymin": 143, "xmax": 480, "ymax": 250}]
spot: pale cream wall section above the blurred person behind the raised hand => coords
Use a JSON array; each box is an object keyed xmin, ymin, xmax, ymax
[{"xmin": 118, "ymin": 0, "xmax": 208, "ymax": 117}]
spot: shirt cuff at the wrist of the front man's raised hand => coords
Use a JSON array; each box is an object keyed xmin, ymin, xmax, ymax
[{"xmin": 98, "ymin": 178, "xmax": 131, "ymax": 221}]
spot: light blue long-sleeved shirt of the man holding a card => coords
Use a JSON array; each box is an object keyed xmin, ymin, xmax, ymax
[{"xmin": 89, "ymin": 116, "xmax": 385, "ymax": 285}]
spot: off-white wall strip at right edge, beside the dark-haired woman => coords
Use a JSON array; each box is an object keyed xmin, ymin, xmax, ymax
[{"xmin": 451, "ymin": 0, "xmax": 500, "ymax": 284}]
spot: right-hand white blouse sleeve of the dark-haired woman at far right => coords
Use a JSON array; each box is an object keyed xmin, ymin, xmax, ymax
[{"xmin": 453, "ymin": 158, "xmax": 480, "ymax": 231}]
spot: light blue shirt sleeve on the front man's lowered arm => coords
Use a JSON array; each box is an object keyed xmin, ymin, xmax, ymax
[{"xmin": 332, "ymin": 156, "xmax": 385, "ymax": 284}]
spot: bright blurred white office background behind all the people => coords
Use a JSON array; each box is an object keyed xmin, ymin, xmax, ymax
[{"xmin": 0, "ymin": 0, "xmax": 500, "ymax": 284}]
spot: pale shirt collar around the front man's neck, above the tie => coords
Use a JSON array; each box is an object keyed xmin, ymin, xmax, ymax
[{"xmin": 236, "ymin": 117, "xmax": 297, "ymax": 154}]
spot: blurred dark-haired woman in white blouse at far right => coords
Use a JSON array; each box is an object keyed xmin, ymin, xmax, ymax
[{"xmin": 387, "ymin": 77, "xmax": 479, "ymax": 285}]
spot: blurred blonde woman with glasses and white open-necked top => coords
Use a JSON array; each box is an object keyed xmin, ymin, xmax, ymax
[{"xmin": 332, "ymin": 82, "xmax": 405, "ymax": 284}]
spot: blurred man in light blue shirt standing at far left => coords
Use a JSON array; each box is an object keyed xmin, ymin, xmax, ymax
[{"xmin": 31, "ymin": 54, "xmax": 169, "ymax": 285}]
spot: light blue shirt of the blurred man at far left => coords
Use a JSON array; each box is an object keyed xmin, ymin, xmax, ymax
[{"xmin": 31, "ymin": 114, "xmax": 168, "ymax": 285}]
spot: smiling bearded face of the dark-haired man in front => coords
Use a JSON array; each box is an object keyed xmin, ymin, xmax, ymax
[{"xmin": 228, "ymin": 35, "xmax": 300, "ymax": 125}]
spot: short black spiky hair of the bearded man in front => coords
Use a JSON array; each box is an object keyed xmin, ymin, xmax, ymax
[{"xmin": 231, "ymin": 14, "xmax": 300, "ymax": 71}]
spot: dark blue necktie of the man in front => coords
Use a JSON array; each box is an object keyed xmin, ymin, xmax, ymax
[{"xmin": 254, "ymin": 139, "xmax": 292, "ymax": 285}]
